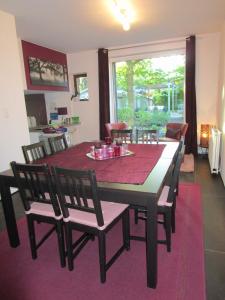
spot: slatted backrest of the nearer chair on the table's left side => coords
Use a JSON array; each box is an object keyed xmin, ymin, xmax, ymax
[{"xmin": 22, "ymin": 141, "xmax": 47, "ymax": 164}]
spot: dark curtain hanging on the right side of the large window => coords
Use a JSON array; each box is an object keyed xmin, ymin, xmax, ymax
[{"xmin": 185, "ymin": 36, "xmax": 197, "ymax": 155}]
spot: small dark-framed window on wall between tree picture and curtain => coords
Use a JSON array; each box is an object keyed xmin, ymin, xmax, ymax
[{"xmin": 71, "ymin": 73, "xmax": 89, "ymax": 101}]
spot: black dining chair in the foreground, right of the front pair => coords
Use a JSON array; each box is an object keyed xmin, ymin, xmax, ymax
[{"xmin": 52, "ymin": 167, "xmax": 130, "ymax": 283}]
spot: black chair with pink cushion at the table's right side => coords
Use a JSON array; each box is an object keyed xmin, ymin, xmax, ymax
[{"xmin": 134, "ymin": 146, "xmax": 185, "ymax": 252}]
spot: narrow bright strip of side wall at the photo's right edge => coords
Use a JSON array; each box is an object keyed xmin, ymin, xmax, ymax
[{"xmin": 218, "ymin": 22, "xmax": 225, "ymax": 185}]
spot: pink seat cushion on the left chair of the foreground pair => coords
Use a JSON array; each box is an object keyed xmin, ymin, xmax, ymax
[{"xmin": 25, "ymin": 202, "xmax": 62, "ymax": 220}]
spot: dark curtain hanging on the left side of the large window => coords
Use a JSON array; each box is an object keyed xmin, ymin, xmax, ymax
[{"xmin": 98, "ymin": 48, "xmax": 110, "ymax": 140}]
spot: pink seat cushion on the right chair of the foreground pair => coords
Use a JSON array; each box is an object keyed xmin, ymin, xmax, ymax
[{"xmin": 64, "ymin": 200, "xmax": 128, "ymax": 230}]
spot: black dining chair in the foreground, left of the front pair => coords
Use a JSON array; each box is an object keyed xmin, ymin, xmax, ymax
[{"xmin": 11, "ymin": 161, "xmax": 66, "ymax": 267}]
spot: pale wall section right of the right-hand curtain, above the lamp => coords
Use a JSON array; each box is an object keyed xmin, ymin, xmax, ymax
[{"xmin": 196, "ymin": 33, "xmax": 221, "ymax": 141}]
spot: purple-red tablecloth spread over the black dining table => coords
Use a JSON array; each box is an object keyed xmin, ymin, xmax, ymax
[{"xmin": 38, "ymin": 142, "xmax": 165, "ymax": 184}]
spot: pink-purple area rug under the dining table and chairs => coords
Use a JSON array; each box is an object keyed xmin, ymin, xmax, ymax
[{"xmin": 0, "ymin": 183, "xmax": 206, "ymax": 300}]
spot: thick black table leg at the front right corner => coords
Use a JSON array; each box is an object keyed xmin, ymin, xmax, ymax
[{"xmin": 146, "ymin": 201, "xmax": 158, "ymax": 288}]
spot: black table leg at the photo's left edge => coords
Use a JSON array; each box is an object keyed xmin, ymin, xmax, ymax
[{"xmin": 0, "ymin": 181, "xmax": 20, "ymax": 248}]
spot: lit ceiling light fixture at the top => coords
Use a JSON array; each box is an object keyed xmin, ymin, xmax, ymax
[{"xmin": 112, "ymin": 0, "xmax": 133, "ymax": 31}]
